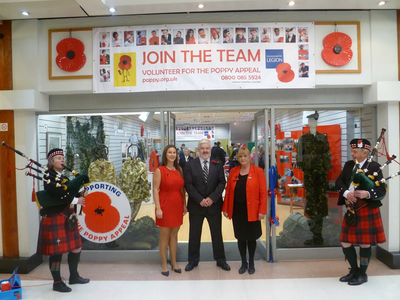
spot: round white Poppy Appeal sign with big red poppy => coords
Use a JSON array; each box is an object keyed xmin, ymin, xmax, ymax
[{"xmin": 78, "ymin": 182, "xmax": 131, "ymax": 243}]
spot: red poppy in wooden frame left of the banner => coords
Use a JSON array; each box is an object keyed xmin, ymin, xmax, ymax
[{"xmin": 56, "ymin": 38, "xmax": 86, "ymax": 72}]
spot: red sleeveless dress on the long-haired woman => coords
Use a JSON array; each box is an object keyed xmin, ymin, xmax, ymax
[{"xmin": 156, "ymin": 166, "xmax": 184, "ymax": 227}]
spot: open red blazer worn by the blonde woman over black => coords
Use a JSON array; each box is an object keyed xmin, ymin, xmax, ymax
[{"xmin": 222, "ymin": 165, "xmax": 267, "ymax": 222}]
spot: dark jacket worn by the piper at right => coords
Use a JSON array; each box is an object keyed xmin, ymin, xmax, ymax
[{"xmin": 336, "ymin": 160, "xmax": 386, "ymax": 207}]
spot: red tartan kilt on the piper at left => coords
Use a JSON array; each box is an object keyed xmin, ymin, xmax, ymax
[{"xmin": 37, "ymin": 208, "xmax": 82, "ymax": 255}]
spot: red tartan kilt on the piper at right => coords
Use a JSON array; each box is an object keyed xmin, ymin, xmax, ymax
[{"xmin": 340, "ymin": 206, "xmax": 386, "ymax": 245}]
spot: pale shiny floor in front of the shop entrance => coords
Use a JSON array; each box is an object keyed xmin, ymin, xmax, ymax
[{"xmin": 0, "ymin": 259, "xmax": 400, "ymax": 300}]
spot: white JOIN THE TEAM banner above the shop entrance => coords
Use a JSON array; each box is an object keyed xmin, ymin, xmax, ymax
[{"xmin": 93, "ymin": 22, "xmax": 315, "ymax": 93}]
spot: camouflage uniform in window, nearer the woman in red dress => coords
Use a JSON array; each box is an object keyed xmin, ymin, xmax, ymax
[{"xmin": 119, "ymin": 158, "xmax": 150, "ymax": 221}]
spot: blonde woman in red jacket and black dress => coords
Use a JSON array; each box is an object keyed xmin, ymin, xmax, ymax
[{"xmin": 222, "ymin": 147, "xmax": 267, "ymax": 274}]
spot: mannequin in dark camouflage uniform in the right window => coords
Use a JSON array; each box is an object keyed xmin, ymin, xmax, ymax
[{"xmin": 297, "ymin": 112, "xmax": 332, "ymax": 246}]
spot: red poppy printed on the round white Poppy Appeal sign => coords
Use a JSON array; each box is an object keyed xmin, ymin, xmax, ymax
[{"xmin": 82, "ymin": 192, "xmax": 120, "ymax": 233}]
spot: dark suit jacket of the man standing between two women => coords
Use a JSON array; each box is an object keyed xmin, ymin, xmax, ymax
[{"xmin": 184, "ymin": 157, "xmax": 226, "ymax": 215}]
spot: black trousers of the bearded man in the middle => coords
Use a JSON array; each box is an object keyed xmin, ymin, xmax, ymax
[{"xmin": 188, "ymin": 213, "xmax": 226, "ymax": 264}]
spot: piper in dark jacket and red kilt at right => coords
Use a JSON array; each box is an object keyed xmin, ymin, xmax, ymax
[{"xmin": 336, "ymin": 139, "xmax": 386, "ymax": 285}]
